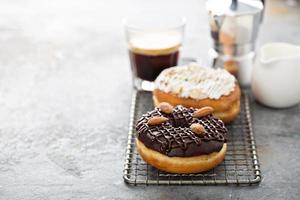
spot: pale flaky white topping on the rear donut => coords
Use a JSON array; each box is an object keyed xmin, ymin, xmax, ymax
[{"xmin": 155, "ymin": 63, "xmax": 235, "ymax": 100}]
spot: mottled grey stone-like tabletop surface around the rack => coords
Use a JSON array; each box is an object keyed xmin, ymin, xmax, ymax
[{"xmin": 0, "ymin": 0, "xmax": 300, "ymax": 200}]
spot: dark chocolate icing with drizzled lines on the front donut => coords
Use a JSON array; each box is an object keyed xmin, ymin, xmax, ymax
[{"xmin": 136, "ymin": 106, "xmax": 227, "ymax": 157}]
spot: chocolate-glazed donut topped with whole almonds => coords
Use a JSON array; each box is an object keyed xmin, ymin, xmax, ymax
[{"xmin": 136, "ymin": 102, "xmax": 227, "ymax": 173}]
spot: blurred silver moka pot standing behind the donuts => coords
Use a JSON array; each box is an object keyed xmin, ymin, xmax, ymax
[{"xmin": 206, "ymin": 0, "xmax": 264, "ymax": 86}]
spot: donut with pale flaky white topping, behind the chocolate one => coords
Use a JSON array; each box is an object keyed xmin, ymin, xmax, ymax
[{"xmin": 153, "ymin": 64, "xmax": 241, "ymax": 124}]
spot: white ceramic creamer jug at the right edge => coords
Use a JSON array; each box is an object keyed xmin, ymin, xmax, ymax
[{"xmin": 251, "ymin": 43, "xmax": 300, "ymax": 108}]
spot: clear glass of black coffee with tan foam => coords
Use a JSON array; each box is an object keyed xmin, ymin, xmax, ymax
[{"xmin": 124, "ymin": 16, "xmax": 185, "ymax": 91}]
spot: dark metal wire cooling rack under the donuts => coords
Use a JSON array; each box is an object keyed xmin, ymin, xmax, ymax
[{"xmin": 123, "ymin": 91, "xmax": 261, "ymax": 185}]
